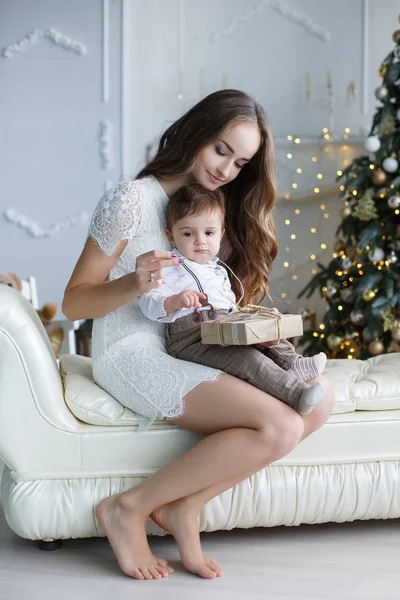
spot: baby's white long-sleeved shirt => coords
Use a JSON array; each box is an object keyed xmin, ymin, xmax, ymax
[{"xmin": 139, "ymin": 248, "xmax": 236, "ymax": 323}]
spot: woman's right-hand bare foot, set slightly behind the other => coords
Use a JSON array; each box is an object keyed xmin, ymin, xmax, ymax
[{"xmin": 150, "ymin": 499, "xmax": 222, "ymax": 579}]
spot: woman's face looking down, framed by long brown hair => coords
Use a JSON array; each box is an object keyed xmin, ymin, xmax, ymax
[{"xmin": 191, "ymin": 123, "xmax": 261, "ymax": 190}]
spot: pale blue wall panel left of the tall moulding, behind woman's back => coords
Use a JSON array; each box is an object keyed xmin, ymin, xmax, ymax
[{"xmin": 0, "ymin": 0, "xmax": 121, "ymax": 309}]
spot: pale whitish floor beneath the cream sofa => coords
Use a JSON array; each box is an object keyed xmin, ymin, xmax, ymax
[{"xmin": 0, "ymin": 458, "xmax": 400, "ymax": 600}]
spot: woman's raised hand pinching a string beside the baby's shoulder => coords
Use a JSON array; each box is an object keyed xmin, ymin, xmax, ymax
[{"xmin": 134, "ymin": 250, "xmax": 183, "ymax": 296}]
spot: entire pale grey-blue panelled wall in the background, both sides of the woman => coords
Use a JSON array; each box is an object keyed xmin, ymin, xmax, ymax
[{"xmin": 0, "ymin": 0, "xmax": 400, "ymax": 310}]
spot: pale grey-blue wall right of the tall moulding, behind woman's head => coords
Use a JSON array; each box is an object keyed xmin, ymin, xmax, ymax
[{"xmin": 123, "ymin": 0, "xmax": 400, "ymax": 312}]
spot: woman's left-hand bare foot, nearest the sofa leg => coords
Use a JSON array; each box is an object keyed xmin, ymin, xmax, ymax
[{"xmin": 95, "ymin": 496, "xmax": 173, "ymax": 579}]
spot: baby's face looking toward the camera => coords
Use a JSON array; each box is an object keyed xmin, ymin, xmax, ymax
[{"xmin": 171, "ymin": 211, "xmax": 224, "ymax": 264}]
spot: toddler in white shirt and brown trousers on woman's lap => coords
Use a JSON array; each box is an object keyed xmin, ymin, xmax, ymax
[{"xmin": 139, "ymin": 183, "xmax": 326, "ymax": 415}]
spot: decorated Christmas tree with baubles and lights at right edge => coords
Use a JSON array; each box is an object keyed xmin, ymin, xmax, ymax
[{"xmin": 299, "ymin": 17, "xmax": 400, "ymax": 359}]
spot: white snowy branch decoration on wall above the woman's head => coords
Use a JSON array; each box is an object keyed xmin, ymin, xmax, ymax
[{"xmin": 211, "ymin": 0, "xmax": 331, "ymax": 42}]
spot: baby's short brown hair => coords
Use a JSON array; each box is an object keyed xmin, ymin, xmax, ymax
[{"xmin": 167, "ymin": 183, "xmax": 225, "ymax": 231}]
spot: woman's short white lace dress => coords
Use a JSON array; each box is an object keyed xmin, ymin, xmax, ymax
[{"xmin": 89, "ymin": 176, "xmax": 220, "ymax": 429}]
